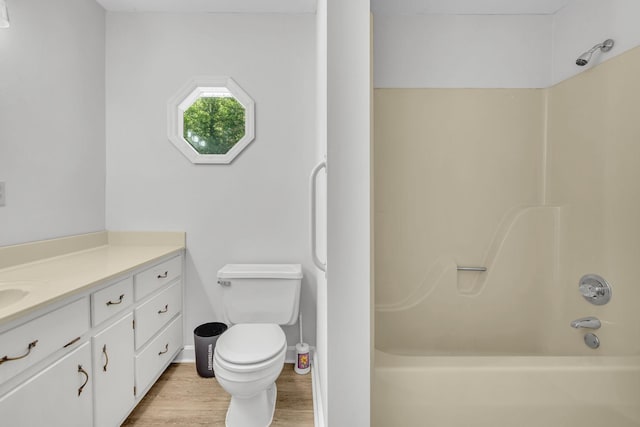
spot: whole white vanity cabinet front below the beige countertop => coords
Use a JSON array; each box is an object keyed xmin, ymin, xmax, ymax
[{"xmin": 0, "ymin": 251, "xmax": 183, "ymax": 427}]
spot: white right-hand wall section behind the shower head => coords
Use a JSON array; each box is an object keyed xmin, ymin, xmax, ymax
[{"xmin": 552, "ymin": 0, "xmax": 640, "ymax": 84}]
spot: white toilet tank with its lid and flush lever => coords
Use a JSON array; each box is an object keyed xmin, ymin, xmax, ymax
[{"xmin": 218, "ymin": 264, "xmax": 302, "ymax": 325}]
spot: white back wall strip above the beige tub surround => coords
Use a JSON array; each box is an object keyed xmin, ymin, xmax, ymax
[{"xmin": 374, "ymin": 15, "xmax": 552, "ymax": 88}]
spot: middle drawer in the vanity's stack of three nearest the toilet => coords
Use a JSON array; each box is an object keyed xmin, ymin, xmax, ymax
[{"xmin": 135, "ymin": 282, "xmax": 182, "ymax": 349}]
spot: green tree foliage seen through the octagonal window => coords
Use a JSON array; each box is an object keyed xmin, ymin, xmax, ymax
[{"xmin": 183, "ymin": 97, "xmax": 245, "ymax": 154}]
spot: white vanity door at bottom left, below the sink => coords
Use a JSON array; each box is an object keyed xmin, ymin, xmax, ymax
[{"xmin": 0, "ymin": 343, "xmax": 93, "ymax": 427}]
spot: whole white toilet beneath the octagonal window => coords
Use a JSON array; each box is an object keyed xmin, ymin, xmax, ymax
[{"xmin": 213, "ymin": 264, "xmax": 302, "ymax": 427}]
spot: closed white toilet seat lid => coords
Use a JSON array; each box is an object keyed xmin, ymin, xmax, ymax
[{"xmin": 215, "ymin": 323, "xmax": 287, "ymax": 371}]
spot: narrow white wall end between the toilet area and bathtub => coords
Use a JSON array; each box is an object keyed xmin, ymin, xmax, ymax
[{"xmin": 327, "ymin": 0, "xmax": 372, "ymax": 427}]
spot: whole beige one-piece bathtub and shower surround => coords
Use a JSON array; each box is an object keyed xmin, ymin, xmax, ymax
[{"xmin": 372, "ymin": 48, "xmax": 640, "ymax": 426}]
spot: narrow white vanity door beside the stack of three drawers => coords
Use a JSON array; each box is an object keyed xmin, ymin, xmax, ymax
[{"xmin": 91, "ymin": 313, "xmax": 135, "ymax": 427}]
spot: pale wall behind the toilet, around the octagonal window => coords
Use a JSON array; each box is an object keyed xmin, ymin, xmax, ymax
[{"xmin": 107, "ymin": 13, "xmax": 316, "ymax": 352}]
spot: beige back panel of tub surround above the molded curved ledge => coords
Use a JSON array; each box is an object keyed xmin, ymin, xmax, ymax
[{"xmin": 374, "ymin": 89, "xmax": 544, "ymax": 304}]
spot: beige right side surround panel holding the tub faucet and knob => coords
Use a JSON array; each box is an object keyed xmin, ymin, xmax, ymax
[{"xmin": 547, "ymin": 48, "xmax": 640, "ymax": 354}]
